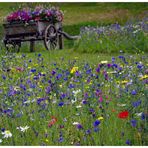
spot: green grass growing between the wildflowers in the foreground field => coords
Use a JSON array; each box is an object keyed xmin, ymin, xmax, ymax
[{"xmin": 0, "ymin": 50, "xmax": 147, "ymax": 146}]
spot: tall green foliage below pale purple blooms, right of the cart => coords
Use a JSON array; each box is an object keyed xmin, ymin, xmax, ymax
[{"xmin": 74, "ymin": 23, "xmax": 148, "ymax": 53}]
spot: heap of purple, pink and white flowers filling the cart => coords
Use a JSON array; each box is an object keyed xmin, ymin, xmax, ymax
[{"xmin": 6, "ymin": 6, "xmax": 63, "ymax": 23}]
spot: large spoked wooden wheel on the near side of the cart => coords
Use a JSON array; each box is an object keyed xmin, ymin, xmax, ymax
[{"xmin": 44, "ymin": 25, "xmax": 57, "ymax": 50}]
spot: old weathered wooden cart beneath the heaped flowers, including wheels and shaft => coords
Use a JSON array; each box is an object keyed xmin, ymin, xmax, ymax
[{"xmin": 3, "ymin": 21, "xmax": 79, "ymax": 52}]
